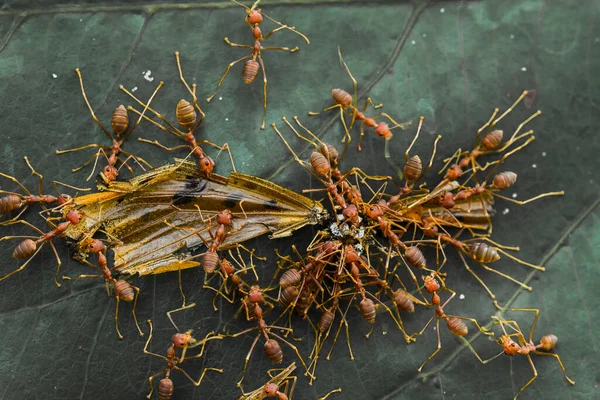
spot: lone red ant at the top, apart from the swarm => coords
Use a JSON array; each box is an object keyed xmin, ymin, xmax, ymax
[{"xmin": 206, "ymin": 0, "xmax": 310, "ymax": 129}]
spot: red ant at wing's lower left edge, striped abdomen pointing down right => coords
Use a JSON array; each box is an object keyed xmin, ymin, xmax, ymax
[{"xmin": 63, "ymin": 239, "xmax": 144, "ymax": 339}]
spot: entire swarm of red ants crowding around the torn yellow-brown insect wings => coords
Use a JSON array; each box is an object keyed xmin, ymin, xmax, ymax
[{"xmin": 0, "ymin": 0, "xmax": 575, "ymax": 400}]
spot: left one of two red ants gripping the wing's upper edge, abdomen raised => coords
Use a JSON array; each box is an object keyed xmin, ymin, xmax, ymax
[{"xmin": 56, "ymin": 68, "xmax": 159, "ymax": 182}]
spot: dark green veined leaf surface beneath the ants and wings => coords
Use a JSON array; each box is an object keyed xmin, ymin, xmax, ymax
[{"xmin": 0, "ymin": 0, "xmax": 600, "ymax": 399}]
